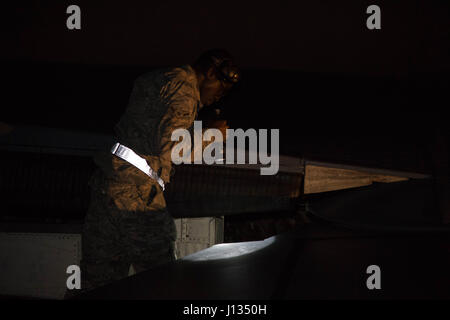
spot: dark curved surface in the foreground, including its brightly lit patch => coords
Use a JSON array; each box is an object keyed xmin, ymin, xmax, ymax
[{"xmin": 77, "ymin": 181, "xmax": 450, "ymax": 300}]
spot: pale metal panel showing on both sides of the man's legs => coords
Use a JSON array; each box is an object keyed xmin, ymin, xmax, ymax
[{"xmin": 0, "ymin": 217, "xmax": 224, "ymax": 299}]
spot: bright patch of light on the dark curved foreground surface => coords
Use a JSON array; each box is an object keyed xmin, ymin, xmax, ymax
[{"xmin": 183, "ymin": 236, "xmax": 276, "ymax": 261}]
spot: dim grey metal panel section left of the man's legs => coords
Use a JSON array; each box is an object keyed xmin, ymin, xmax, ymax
[{"xmin": 0, "ymin": 233, "xmax": 81, "ymax": 299}]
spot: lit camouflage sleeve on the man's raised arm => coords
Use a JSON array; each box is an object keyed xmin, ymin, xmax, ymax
[{"xmin": 158, "ymin": 72, "xmax": 198, "ymax": 182}]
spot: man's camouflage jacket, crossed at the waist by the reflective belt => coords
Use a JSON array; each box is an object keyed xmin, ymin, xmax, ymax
[{"xmin": 96, "ymin": 65, "xmax": 202, "ymax": 184}]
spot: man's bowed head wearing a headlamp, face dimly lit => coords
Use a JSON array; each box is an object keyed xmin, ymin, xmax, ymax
[{"xmin": 193, "ymin": 49, "xmax": 239, "ymax": 106}]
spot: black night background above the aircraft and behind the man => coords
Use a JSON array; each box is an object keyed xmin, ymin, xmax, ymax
[{"xmin": 0, "ymin": 0, "xmax": 450, "ymax": 172}]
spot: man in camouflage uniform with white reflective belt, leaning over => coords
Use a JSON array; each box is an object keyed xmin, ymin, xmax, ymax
[{"xmin": 67, "ymin": 50, "xmax": 238, "ymax": 296}]
